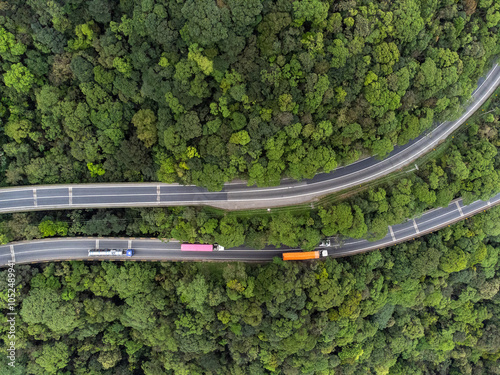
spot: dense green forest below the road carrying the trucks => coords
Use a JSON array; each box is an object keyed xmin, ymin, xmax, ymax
[{"xmin": 0, "ymin": 208, "xmax": 500, "ymax": 375}]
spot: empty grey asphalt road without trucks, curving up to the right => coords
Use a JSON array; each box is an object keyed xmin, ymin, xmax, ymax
[{"xmin": 0, "ymin": 64, "xmax": 500, "ymax": 213}]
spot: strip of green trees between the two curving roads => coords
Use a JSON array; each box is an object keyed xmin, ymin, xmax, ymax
[{"xmin": 0, "ymin": 90, "xmax": 500, "ymax": 250}]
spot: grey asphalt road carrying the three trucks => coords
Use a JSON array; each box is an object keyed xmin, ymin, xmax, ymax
[{"xmin": 0, "ymin": 193, "xmax": 500, "ymax": 267}]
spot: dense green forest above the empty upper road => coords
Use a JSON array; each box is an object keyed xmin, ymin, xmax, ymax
[{"xmin": 0, "ymin": 0, "xmax": 500, "ymax": 190}]
